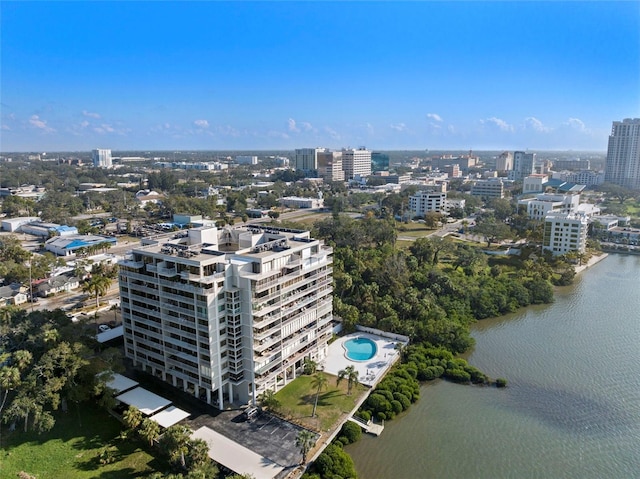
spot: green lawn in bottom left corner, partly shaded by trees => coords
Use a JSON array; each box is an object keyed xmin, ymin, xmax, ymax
[{"xmin": 0, "ymin": 405, "xmax": 167, "ymax": 479}]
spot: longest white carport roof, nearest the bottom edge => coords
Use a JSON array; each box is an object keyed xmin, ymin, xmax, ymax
[{"xmin": 191, "ymin": 426, "xmax": 284, "ymax": 479}]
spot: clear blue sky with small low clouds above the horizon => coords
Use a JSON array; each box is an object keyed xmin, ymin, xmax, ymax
[{"xmin": 0, "ymin": 0, "xmax": 640, "ymax": 151}]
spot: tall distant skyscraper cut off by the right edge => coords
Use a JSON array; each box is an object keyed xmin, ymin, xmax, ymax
[{"xmin": 604, "ymin": 118, "xmax": 640, "ymax": 190}]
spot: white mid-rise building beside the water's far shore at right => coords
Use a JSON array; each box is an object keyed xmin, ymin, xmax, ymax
[{"xmin": 542, "ymin": 213, "xmax": 589, "ymax": 256}]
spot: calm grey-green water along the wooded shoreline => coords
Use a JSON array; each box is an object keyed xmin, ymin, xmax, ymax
[{"xmin": 347, "ymin": 255, "xmax": 640, "ymax": 479}]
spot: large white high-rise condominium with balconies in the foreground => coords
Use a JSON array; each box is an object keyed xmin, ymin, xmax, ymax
[{"xmin": 119, "ymin": 225, "xmax": 333, "ymax": 408}]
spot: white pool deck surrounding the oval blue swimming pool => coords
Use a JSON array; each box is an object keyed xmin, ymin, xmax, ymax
[{"xmin": 320, "ymin": 332, "xmax": 399, "ymax": 387}]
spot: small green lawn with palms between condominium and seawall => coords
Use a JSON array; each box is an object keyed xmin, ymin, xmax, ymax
[{"xmin": 276, "ymin": 373, "xmax": 368, "ymax": 431}]
